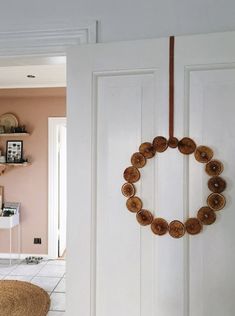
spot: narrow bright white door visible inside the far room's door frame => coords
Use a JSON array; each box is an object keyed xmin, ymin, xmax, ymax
[{"xmin": 59, "ymin": 125, "xmax": 67, "ymax": 257}]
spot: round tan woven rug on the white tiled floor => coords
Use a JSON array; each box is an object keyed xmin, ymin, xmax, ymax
[{"xmin": 0, "ymin": 280, "xmax": 50, "ymax": 316}]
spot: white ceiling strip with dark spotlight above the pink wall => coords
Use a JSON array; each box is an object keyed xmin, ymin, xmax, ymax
[{"xmin": 0, "ymin": 57, "xmax": 66, "ymax": 89}]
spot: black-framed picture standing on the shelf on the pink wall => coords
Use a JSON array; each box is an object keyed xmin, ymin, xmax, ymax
[{"xmin": 6, "ymin": 140, "xmax": 23, "ymax": 163}]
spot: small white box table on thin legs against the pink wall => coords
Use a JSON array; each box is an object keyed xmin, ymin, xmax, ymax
[{"xmin": 0, "ymin": 213, "xmax": 20, "ymax": 265}]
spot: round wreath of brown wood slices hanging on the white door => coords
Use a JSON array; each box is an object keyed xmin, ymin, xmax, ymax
[{"xmin": 121, "ymin": 136, "xmax": 226, "ymax": 238}]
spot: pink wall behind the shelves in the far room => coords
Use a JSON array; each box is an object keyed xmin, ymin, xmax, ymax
[{"xmin": 0, "ymin": 88, "xmax": 66, "ymax": 254}]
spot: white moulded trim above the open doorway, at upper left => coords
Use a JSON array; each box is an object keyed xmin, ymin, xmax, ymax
[{"xmin": 0, "ymin": 21, "xmax": 97, "ymax": 57}]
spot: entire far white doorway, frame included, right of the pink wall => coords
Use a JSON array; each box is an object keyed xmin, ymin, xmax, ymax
[{"xmin": 48, "ymin": 117, "xmax": 67, "ymax": 259}]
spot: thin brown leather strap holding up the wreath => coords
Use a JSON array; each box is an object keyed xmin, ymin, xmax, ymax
[{"xmin": 169, "ymin": 36, "xmax": 175, "ymax": 138}]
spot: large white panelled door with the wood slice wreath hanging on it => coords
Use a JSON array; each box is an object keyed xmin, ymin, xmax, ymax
[{"xmin": 67, "ymin": 33, "xmax": 235, "ymax": 316}]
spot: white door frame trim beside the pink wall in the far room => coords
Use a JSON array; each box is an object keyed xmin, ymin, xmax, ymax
[{"xmin": 48, "ymin": 117, "xmax": 66, "ymax": 259}]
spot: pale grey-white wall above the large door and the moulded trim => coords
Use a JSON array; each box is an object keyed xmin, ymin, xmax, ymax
[{"xmin": 0, "ymin": 0, "xmax": 235, "ymax": 42}]
